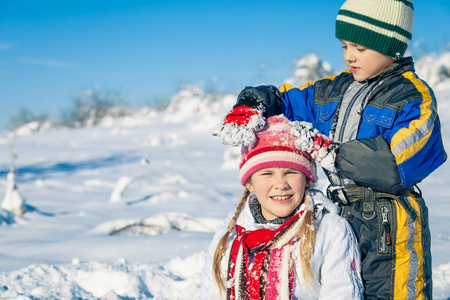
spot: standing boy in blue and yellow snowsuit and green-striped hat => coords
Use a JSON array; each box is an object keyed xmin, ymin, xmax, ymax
[{"xmin": 214, "ymin": 0, "xmax": 447, "ymax": 299}]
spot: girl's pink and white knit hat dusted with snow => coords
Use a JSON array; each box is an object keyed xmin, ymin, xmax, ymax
[{"xmin": 239, "ymin": 115, "xmax": 317, "ymax": 186}]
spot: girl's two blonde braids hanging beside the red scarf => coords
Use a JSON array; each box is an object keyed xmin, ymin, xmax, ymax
[{"xmin": 212, "ymin": 188, "xmax": 316, "ymax": 292}]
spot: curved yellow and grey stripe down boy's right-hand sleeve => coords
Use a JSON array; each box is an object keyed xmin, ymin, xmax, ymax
[{"xmin": 391, "ymin": 72, "xmax": 437, "ymax": 164}]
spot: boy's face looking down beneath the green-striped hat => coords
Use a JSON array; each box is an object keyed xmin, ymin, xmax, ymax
[{"xmin": 341, "ymin": 40, "xmax": 394, "ymax": 81}]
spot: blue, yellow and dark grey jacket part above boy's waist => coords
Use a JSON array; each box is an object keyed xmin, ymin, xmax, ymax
[{"xmin": 279, "ymin": 57, "xmax": 447, "ymax": 194}]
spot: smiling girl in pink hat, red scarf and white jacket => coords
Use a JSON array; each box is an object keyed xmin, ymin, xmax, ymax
[{"xmin": 201, "ymin": 116, "xmax": 363, "ymax": 300}]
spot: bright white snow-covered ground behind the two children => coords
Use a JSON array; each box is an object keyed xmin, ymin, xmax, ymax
[{"xmin": 0, "ymin": 54, "xmax": 450, "ymax": 299}]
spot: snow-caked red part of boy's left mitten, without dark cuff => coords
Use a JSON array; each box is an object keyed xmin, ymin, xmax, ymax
[{"xmin": 213, "ymin": 106, "xmax": 265, "ymax": 146}]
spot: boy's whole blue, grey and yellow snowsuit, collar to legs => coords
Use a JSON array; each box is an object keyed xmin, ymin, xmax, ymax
[{"xmin": 278, "ymin": 57, "xmax": 447, "ymax": 300}]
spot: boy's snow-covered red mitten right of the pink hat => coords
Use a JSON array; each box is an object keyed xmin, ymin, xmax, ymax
[{"xmin": 291, "ymin": 121, "xmax": 339, "ymax": 172}]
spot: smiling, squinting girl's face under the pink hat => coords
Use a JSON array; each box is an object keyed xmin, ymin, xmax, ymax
[{"xmin": 246, "ymin": 168, "xmax": 306, "ymax": 220}]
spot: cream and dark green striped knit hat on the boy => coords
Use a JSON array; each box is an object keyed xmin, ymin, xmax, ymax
[{"xmin": 336, "ymin": 0, "xmax": 414, "ymax": 60}]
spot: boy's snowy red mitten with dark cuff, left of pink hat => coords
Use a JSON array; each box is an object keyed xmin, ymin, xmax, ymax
[{"xmin": 213, "ymin": 85, "xmax": 281, "ymax": 146}]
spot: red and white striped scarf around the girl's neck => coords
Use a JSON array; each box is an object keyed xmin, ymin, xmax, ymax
[{"xmin": 227, "ymin": 211, "xmax": 303, "ymax": 300}]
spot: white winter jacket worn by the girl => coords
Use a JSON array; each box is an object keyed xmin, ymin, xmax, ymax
[{"xmin": 200, "ymin": 189, "xmax": 363, "ymax": 300}]
